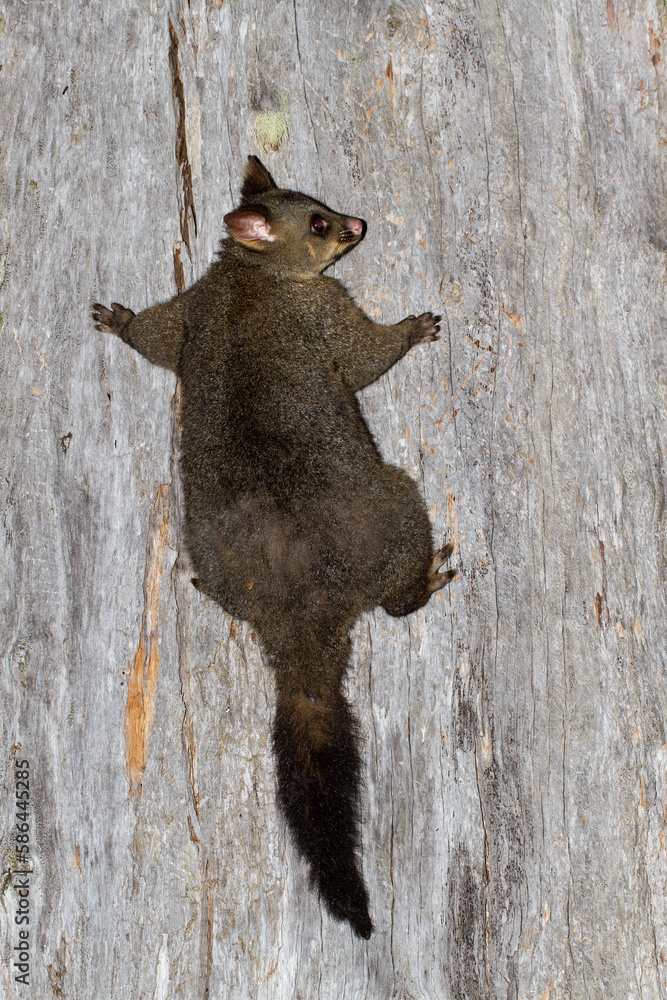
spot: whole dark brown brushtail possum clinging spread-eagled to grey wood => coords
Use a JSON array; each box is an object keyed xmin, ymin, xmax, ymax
[{"xmin": 93, "ymin": 156, "xmax": 454, "ymax": 938}]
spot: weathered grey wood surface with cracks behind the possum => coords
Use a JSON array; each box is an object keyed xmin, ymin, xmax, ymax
[{"xmin": 0, "ymin": 0, "xmax": 667, "ymax": 1000}]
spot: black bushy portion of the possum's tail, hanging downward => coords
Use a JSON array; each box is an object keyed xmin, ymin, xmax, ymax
[{"xmin": 273, "ymin": 670, "xmax": 373, "ymax": 939}]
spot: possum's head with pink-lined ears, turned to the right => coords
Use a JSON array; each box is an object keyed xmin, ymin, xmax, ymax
[{"xmin": 225, "ymin": 156, "xmax": 366, "ymax": 279}]
